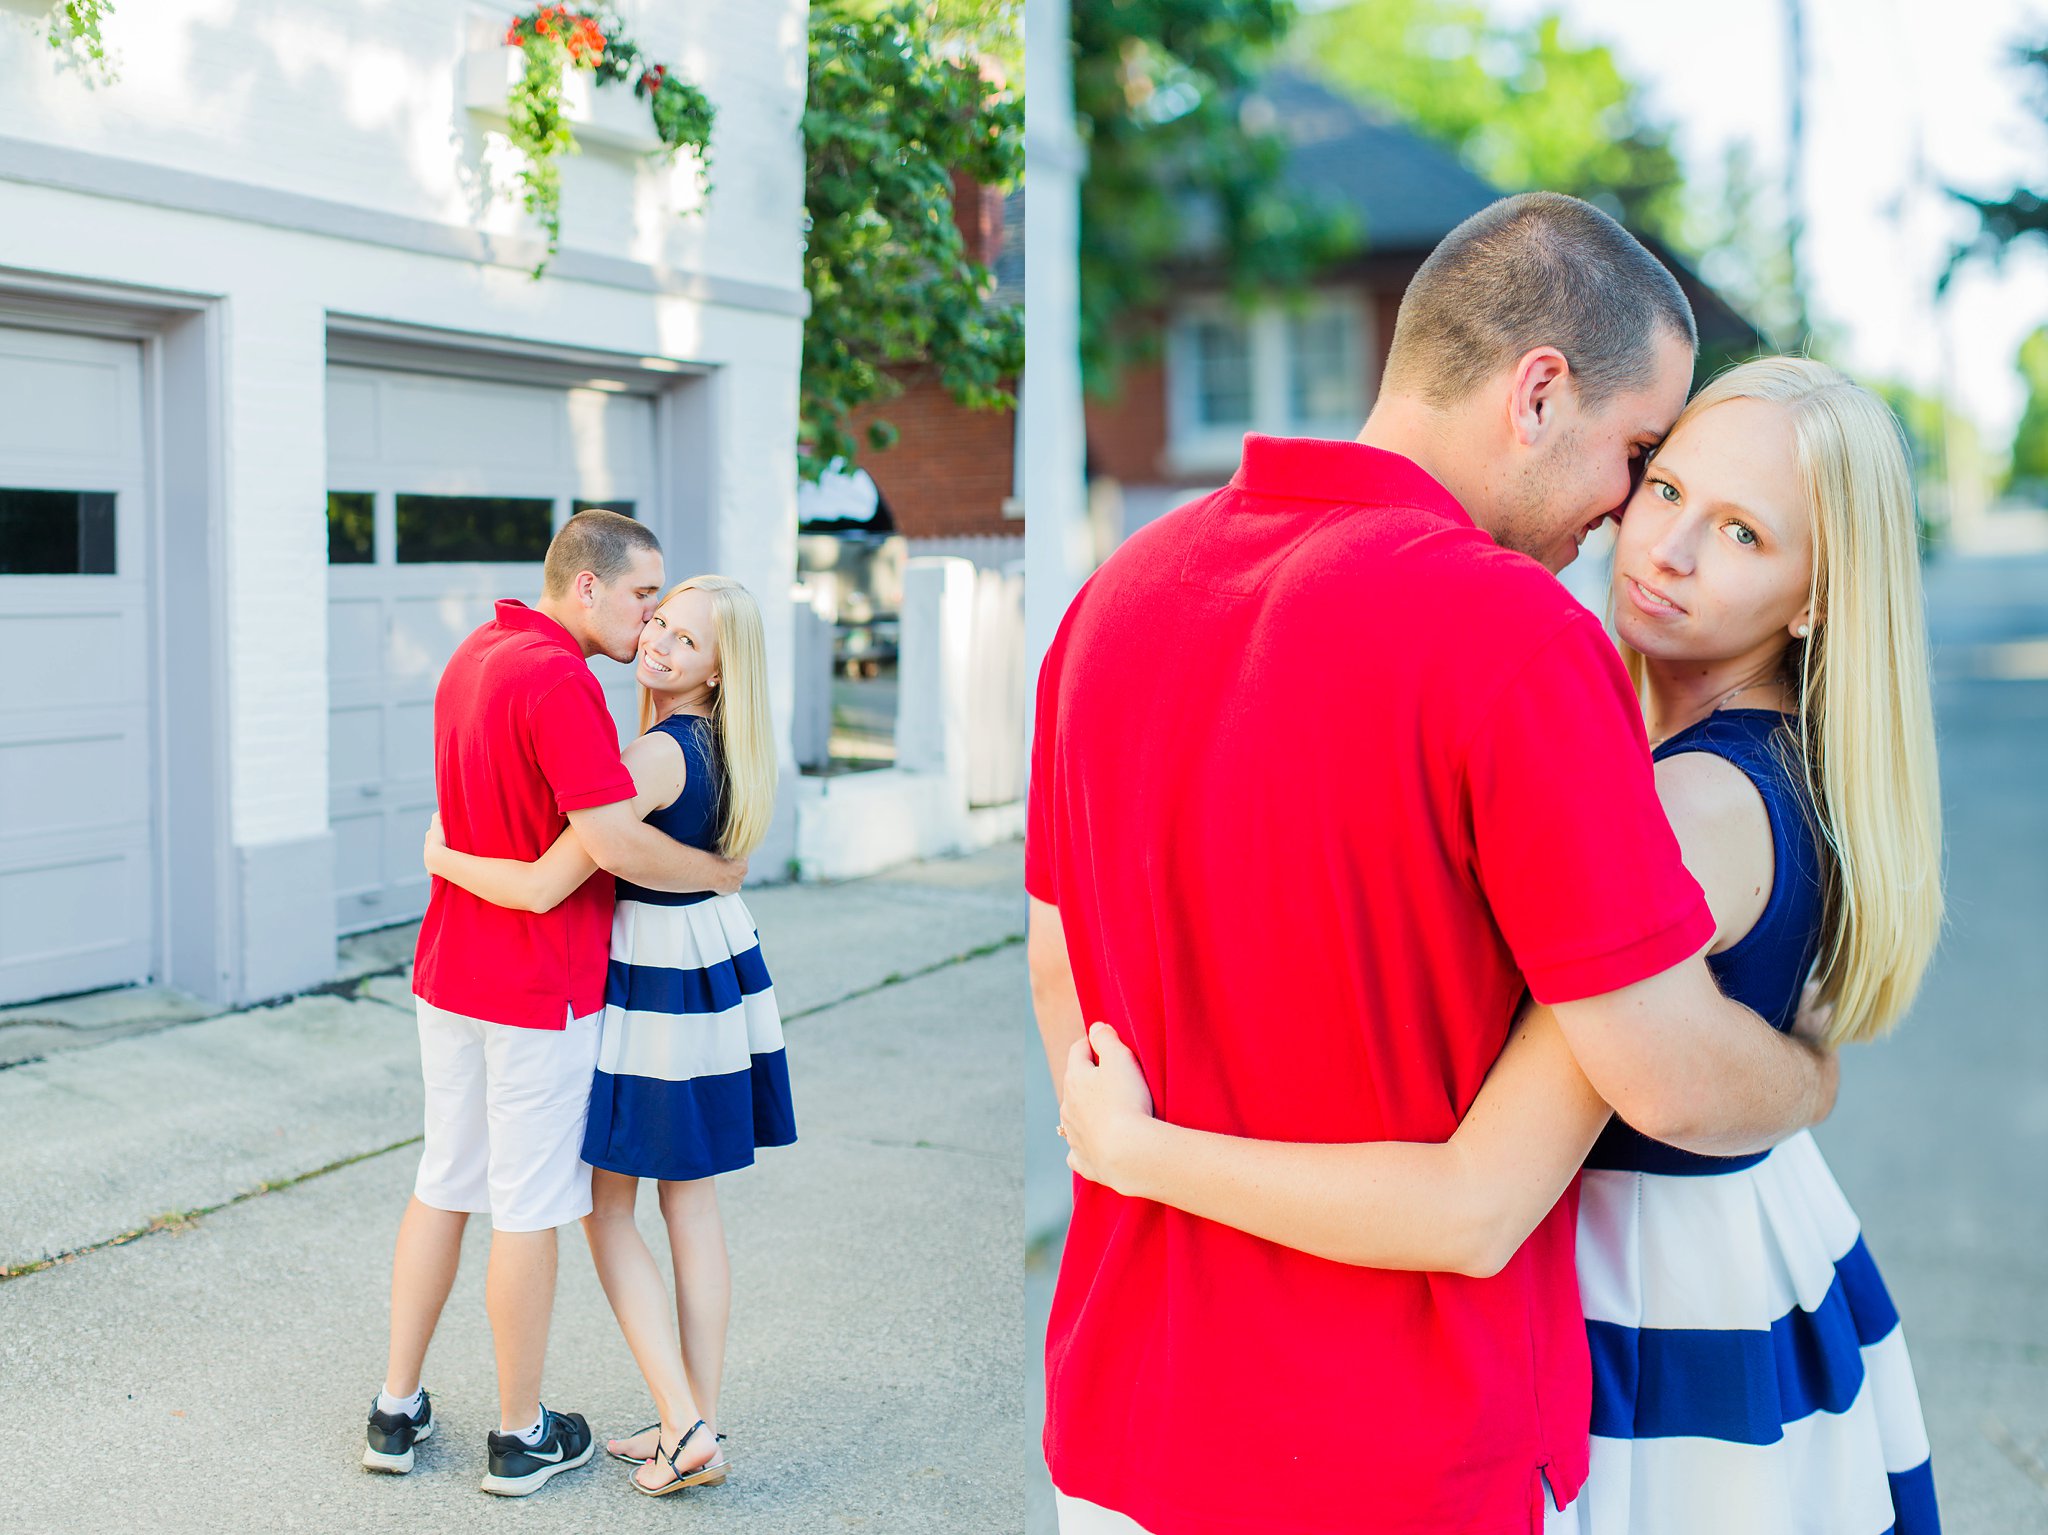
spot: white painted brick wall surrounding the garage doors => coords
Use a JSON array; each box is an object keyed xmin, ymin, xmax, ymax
[{"xmin": 0, "ymin": 0, "xmax": 805, "ymax": 845}]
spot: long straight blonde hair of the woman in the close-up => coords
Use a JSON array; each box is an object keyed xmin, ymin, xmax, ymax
[{"xmin": 1622, "ymin": 356, "xmax": 1942, "ymax": 1044}]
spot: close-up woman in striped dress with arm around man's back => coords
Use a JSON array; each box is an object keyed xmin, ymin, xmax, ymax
[{"xmin": 1061, "ymin": 358, "xmax": 1942, "ymax": 1535}]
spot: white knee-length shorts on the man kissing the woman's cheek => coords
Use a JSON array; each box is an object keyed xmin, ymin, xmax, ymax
[{"xmin": 412, "ymin": 997, "xmax": 598, "ymax": 1232}]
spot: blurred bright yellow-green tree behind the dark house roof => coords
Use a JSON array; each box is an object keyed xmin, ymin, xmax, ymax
[{"xmin": 1292, "ymin": 0, "xmax": 1688, "ymax": 246}]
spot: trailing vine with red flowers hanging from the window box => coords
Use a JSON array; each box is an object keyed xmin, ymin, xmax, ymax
[{"xmin": 506, "ymin": 4, "xmax": 715, "ymax": 278}]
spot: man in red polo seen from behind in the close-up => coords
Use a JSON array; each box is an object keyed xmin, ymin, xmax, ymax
[{"xmin": 1026, "ymin": 194, "xmax": 1833, "ymax": 1535}]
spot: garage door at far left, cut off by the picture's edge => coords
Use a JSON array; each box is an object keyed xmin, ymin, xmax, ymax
[{"xmin": 0, "ymin": 327, "xmax": 160, "ymax": 1003}]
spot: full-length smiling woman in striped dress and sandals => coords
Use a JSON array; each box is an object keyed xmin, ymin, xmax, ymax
[{"xmin": 428, "ymin": 575, "xmax": 797, "ymax": 1496}]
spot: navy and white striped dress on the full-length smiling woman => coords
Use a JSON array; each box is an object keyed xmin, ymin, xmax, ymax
[{"xmin": 584, "ymin": 714, "xmax": 797, "ymax": 1181}]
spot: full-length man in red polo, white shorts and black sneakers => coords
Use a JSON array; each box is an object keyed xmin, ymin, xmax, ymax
[{"xmin": 362, "ymin": 512, "xmax": 745, "ymax": 1496}]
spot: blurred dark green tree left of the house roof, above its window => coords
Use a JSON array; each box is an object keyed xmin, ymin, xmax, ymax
[{"xmin": 1071, "ymin": 0, "xmax": 1356, "ymax": 395}]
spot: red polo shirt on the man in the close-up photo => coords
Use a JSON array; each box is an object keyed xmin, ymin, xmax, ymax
[{"xmin": 1026, "ymin": 436, "xmax": 1712, "ymax": 1535}]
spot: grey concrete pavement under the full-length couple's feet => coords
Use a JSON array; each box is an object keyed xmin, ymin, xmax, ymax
[{"xmin": 0, "ymin": 845, "xmax": 1030, "ymax": 1535}]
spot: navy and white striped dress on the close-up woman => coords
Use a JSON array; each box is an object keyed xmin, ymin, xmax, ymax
[{"xmin": 1546, "ymin": 708, "xmax": 1939, "ymax": 1535}]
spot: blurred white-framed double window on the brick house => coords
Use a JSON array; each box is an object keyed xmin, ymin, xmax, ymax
[{"xmin": 1165, "ymin": 291, "xmax": 1372, "ymax": 475}]
